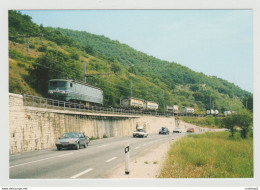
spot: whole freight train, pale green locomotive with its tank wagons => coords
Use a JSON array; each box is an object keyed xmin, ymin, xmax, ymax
[{"xmin": 48, "ymin": 79, "xmax": 230, "ymax": 116}]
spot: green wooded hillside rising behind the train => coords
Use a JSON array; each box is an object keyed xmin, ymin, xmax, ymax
[{"xmin": 9, "ymin": 11, "xmax": 251, "ymax": 113}]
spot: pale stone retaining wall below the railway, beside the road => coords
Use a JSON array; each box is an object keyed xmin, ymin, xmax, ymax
[{"xmin": 9, "ymin": 93, "xmax": 179, "ymax": 154}]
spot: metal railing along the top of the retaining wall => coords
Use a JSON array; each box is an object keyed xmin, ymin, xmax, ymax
[{"xmin": 23, "ymin": 94, "xmax": 177, "ymax": 116}]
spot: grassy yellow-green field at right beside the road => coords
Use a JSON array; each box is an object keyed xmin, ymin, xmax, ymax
[{"xmin": 159, "ymin": 132, "xmax": 253, "ymax": 178}]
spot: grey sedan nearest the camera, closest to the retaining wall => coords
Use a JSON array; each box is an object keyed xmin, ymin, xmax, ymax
[{"xmin": 56, "ymin": 132, "xmax": 90, "ymax": 150}]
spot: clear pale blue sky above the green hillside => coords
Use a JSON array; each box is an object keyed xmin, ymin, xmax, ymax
[{"xmin": 21, "ymin": 10, "xmax": 254, "ymax": 92}]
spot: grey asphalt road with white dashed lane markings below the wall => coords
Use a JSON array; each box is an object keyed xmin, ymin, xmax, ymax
[{"xmin": 9, "ymin": 134, "xmax": 185, "ymax": 179}]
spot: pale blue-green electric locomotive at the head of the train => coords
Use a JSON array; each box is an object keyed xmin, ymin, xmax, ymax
[{"xmin": 48, "ymin": 79, "xmax": 103, "ymax": 105}]
